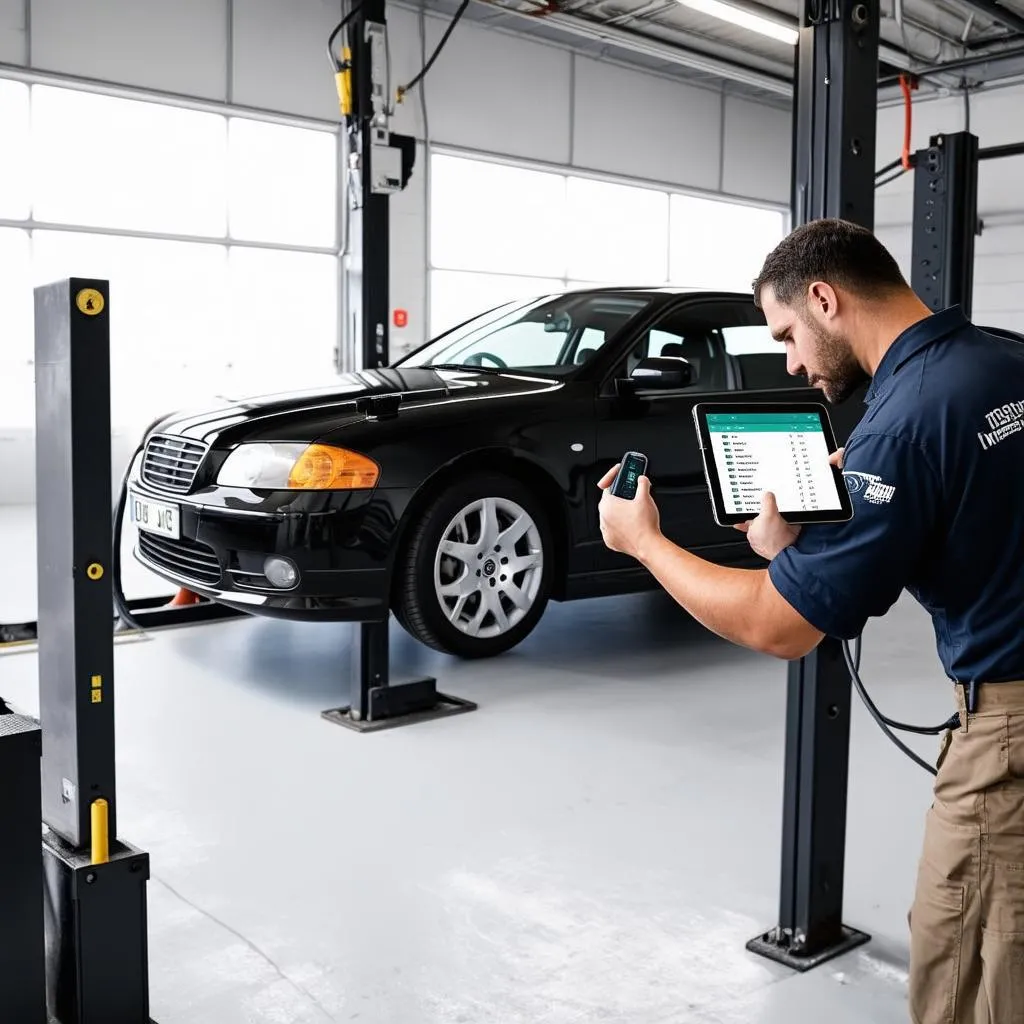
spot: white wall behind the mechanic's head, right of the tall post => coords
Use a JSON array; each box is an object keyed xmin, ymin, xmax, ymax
[{"xmin": 876, "ymin": 88, "xmax": 1024, "ymax": 331}]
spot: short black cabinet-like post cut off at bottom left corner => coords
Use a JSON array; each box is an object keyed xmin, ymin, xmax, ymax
[{"xmin": 0, "ymin": 700, "xmax": 46, "ymax": 1024}]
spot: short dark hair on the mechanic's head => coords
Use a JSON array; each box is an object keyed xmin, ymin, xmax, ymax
[{"xmin": 754, "ymin": 218, "xmax": 908, "ymax": 307}]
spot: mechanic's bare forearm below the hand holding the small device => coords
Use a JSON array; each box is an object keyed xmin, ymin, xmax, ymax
[{"xmin": 637, "ymin": 534, "xmax": 820, "ymax": 658}]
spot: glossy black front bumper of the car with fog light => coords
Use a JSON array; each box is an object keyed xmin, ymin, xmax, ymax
[{"xmin": 126, "ymin": 466, "xmax": 404, "ymax": 622}]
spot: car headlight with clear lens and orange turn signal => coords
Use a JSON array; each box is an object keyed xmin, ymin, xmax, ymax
[{"xmin": 217, "ymin": 443, "xmax": 380, "ymax": 490}]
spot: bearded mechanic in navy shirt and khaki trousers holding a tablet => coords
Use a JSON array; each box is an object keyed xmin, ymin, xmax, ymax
[{"xmin": 599, "ymin": 220, "xmax": 1024, "ymax": 1024}]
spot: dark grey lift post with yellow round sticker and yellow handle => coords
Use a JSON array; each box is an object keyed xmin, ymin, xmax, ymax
[{"xmin": 35, "ymin": 278, "xmax": 150, "ymax": 1024}]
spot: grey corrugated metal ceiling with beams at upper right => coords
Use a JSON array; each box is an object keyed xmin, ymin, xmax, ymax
[{"xmin": 417, "ymin": 0, "xmax": 1024, "ymax": 104}]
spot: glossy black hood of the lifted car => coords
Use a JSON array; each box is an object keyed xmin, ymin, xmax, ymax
[{"xmin": 148, "ymin": 367, "xmax": 560, "ymax": 444}]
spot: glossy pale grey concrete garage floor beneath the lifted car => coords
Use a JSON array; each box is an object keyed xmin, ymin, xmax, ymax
[{"xmin": 0, "ymin": 509, "xmax": 950, "ymax": 1024}]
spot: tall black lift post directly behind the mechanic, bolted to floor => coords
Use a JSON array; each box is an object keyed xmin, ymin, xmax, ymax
[{"xmin": 746, "ymin": 0, "xmax": 880, "ymax": 971}]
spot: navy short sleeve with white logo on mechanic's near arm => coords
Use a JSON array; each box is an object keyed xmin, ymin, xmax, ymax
[{"xmin": 768, "ymin": 432, "xmax": 941, "ymax": 640}]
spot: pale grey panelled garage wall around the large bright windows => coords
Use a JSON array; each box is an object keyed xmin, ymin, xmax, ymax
[{"xmin": 0, "ymin": 0, "xmax": 790, "ymax": 504}]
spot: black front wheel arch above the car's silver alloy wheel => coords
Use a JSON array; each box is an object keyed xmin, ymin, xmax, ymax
[{"xmin": 391, "ymin": 446, "xmax": 571, "ymax": 604}]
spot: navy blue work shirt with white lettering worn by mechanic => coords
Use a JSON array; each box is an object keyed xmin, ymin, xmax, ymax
[{"xmin": 768, "ymin": 306, "xmax": 1024, "ymax": 682}]
